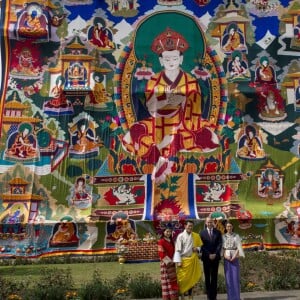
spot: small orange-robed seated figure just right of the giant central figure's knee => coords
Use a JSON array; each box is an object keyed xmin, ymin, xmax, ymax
[{"xmin": 237, "ymin": 125, "xmax": 266, "ymax": 160}]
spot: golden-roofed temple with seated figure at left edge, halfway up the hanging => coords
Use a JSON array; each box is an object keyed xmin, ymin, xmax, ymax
[{"xmin": 1, "ymin": 91, "xmax": 68, "ymax": 172}]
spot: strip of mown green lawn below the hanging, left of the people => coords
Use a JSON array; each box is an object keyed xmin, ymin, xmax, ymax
[{"xmin": 0, "ymin": 262, "xmax": 160, "ymax": 287}]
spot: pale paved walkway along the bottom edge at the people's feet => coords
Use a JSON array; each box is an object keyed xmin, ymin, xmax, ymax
[{"xmin": 136, "ymin": 290, "xmax": 300, "ymax": 300}]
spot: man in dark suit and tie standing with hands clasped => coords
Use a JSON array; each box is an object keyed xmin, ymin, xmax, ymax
[{"xmin": 200, "ymin": 217, "xmax": 222, "ymax": 300}]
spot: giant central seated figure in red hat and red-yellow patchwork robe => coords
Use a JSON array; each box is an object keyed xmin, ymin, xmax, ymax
[{"xmin": 122, "ymin": 28, "xmax": 219, "ymax": 178}]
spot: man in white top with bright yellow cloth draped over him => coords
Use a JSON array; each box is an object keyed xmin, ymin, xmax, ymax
[{"xmin": 174, "ymin": 220, "xmax": 202, "ymax": 300}]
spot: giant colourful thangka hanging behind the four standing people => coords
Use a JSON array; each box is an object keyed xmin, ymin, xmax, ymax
[{"xmin": 0, "ymin": 0, "xmax": 300, "ymax": 257}]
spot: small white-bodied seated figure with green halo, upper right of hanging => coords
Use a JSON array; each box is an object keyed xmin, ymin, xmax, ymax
[{"xmin": 228, "ymin": 50, "xmax": 251, "ymax": 81}]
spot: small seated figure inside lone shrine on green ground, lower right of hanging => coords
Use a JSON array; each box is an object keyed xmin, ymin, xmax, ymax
[{"xmin": 258, "ymin": 168, "xmax": 282, "ymax": 198}]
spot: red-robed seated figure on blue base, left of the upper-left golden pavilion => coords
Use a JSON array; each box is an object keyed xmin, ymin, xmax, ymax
[{"xmin": 44, "ymin": 76, "xmax": 73, "ymax": 112}]
